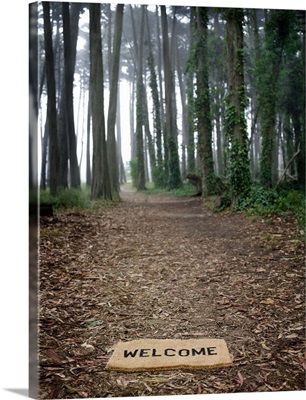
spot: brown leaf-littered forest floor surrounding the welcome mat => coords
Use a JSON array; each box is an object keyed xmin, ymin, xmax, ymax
[{"xmin": 39, "ymin": 186, "xmax": 306, "ymax": 399}]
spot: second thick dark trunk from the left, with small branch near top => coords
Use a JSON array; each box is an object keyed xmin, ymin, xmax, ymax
[{"xmin": 62, "ymin": 3, "xmax": 81, "ymax": 187}]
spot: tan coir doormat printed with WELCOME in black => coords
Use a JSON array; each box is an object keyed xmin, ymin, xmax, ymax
[{"xmin": 106, "ymin": 339, "xmax": 232, "ymax": 372}]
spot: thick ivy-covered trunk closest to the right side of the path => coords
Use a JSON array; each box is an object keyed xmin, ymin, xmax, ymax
[{"xmin": 225, "ymin": 9, "xmax": 251, "ymax": 207}]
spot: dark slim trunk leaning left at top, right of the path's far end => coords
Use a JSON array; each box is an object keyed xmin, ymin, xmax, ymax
[{"xmin": 160, "ymin": 6, "xmax": 182, "ymax": 190}]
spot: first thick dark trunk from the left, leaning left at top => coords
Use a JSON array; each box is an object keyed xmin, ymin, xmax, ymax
[{"xmin": 42, "ymin": 2, "xmax": 59, "ymax": 196}]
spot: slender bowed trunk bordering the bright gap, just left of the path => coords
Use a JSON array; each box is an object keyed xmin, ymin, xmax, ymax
[{"xmin": 107, "ymin": 4, "xmax": 124, "ymax": 193}]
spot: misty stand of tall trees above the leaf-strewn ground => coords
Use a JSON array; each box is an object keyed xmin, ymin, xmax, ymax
[{"xmin": 32, "ymin": 2, "xmax": 305, "ymax": 214}]
